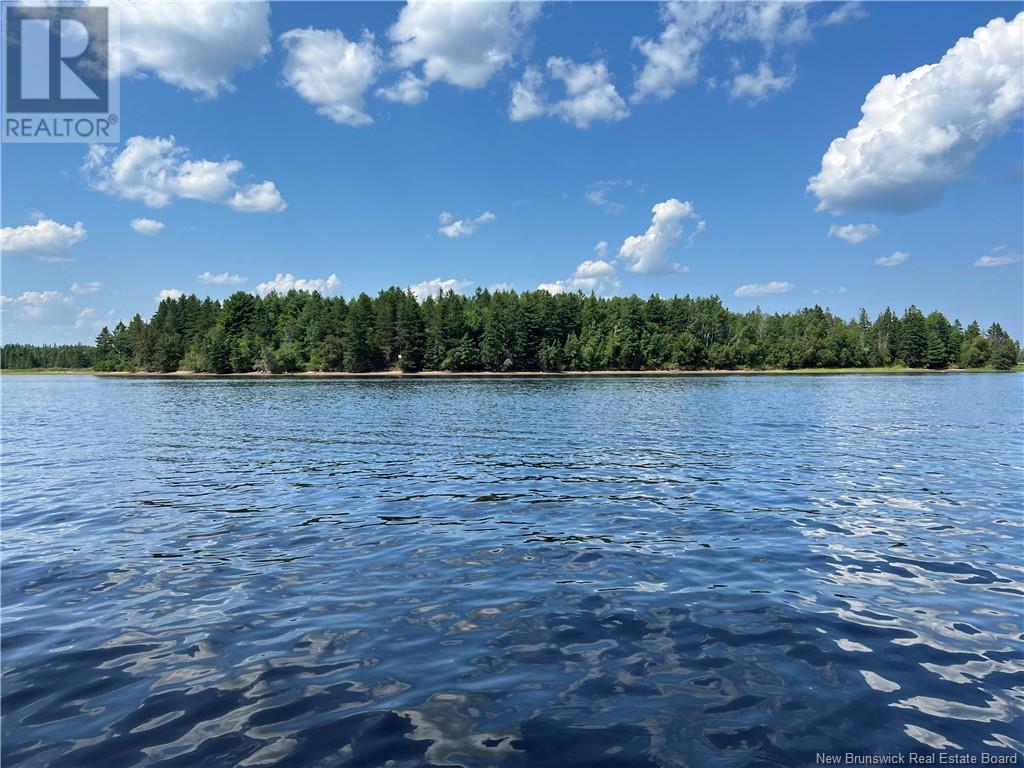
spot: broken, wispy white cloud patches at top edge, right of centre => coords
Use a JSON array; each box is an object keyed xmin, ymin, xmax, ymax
[{"xmin": 630, "ymin": 0, "xmax": 815, "ymax": 102}]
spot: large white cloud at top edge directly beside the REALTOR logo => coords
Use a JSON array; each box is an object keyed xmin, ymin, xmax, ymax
[{"xmin": 111, "ymin": 0, "xmax": 270, "ymax": 98}]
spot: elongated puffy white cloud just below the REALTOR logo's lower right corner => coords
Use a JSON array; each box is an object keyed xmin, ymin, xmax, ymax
[{"xmin": 82, "ymin": 136, "xmax": 286, "ymax": 213}]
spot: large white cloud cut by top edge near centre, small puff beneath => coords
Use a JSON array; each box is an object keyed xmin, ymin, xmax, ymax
[{"xmin": 388, "ymin": 0, "xmax": 540, "ymax": 97}]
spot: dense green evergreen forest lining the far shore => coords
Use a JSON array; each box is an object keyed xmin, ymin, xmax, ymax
[{"xmin": 2, "ymin": 288, "xmax": 1021, "ymax": 374}]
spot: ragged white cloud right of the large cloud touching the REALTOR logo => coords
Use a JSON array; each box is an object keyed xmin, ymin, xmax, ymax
[{"xmin": 281, "ymin": 29, "xmax": 381, "ymax": 126}]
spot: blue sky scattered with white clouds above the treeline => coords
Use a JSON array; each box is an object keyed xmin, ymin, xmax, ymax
[{"xmin": 0, "ymin": 0, "xmax": 1024, "ymax": 343}]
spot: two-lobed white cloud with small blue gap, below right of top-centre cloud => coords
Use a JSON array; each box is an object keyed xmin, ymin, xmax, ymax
[{"xmin": 509, "ymin": 56, "xmax": 630, "ymax": 128}]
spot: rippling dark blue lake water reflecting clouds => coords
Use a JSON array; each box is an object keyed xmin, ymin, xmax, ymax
[{"xmin": 0, "ymin": 374, "xmax": 1024, "ymax": 768}]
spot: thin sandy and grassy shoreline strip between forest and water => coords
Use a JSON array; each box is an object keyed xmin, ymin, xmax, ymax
[{"xmin": 0, "ymin": 365, "xmax": 1024, "ymax": 379}]
